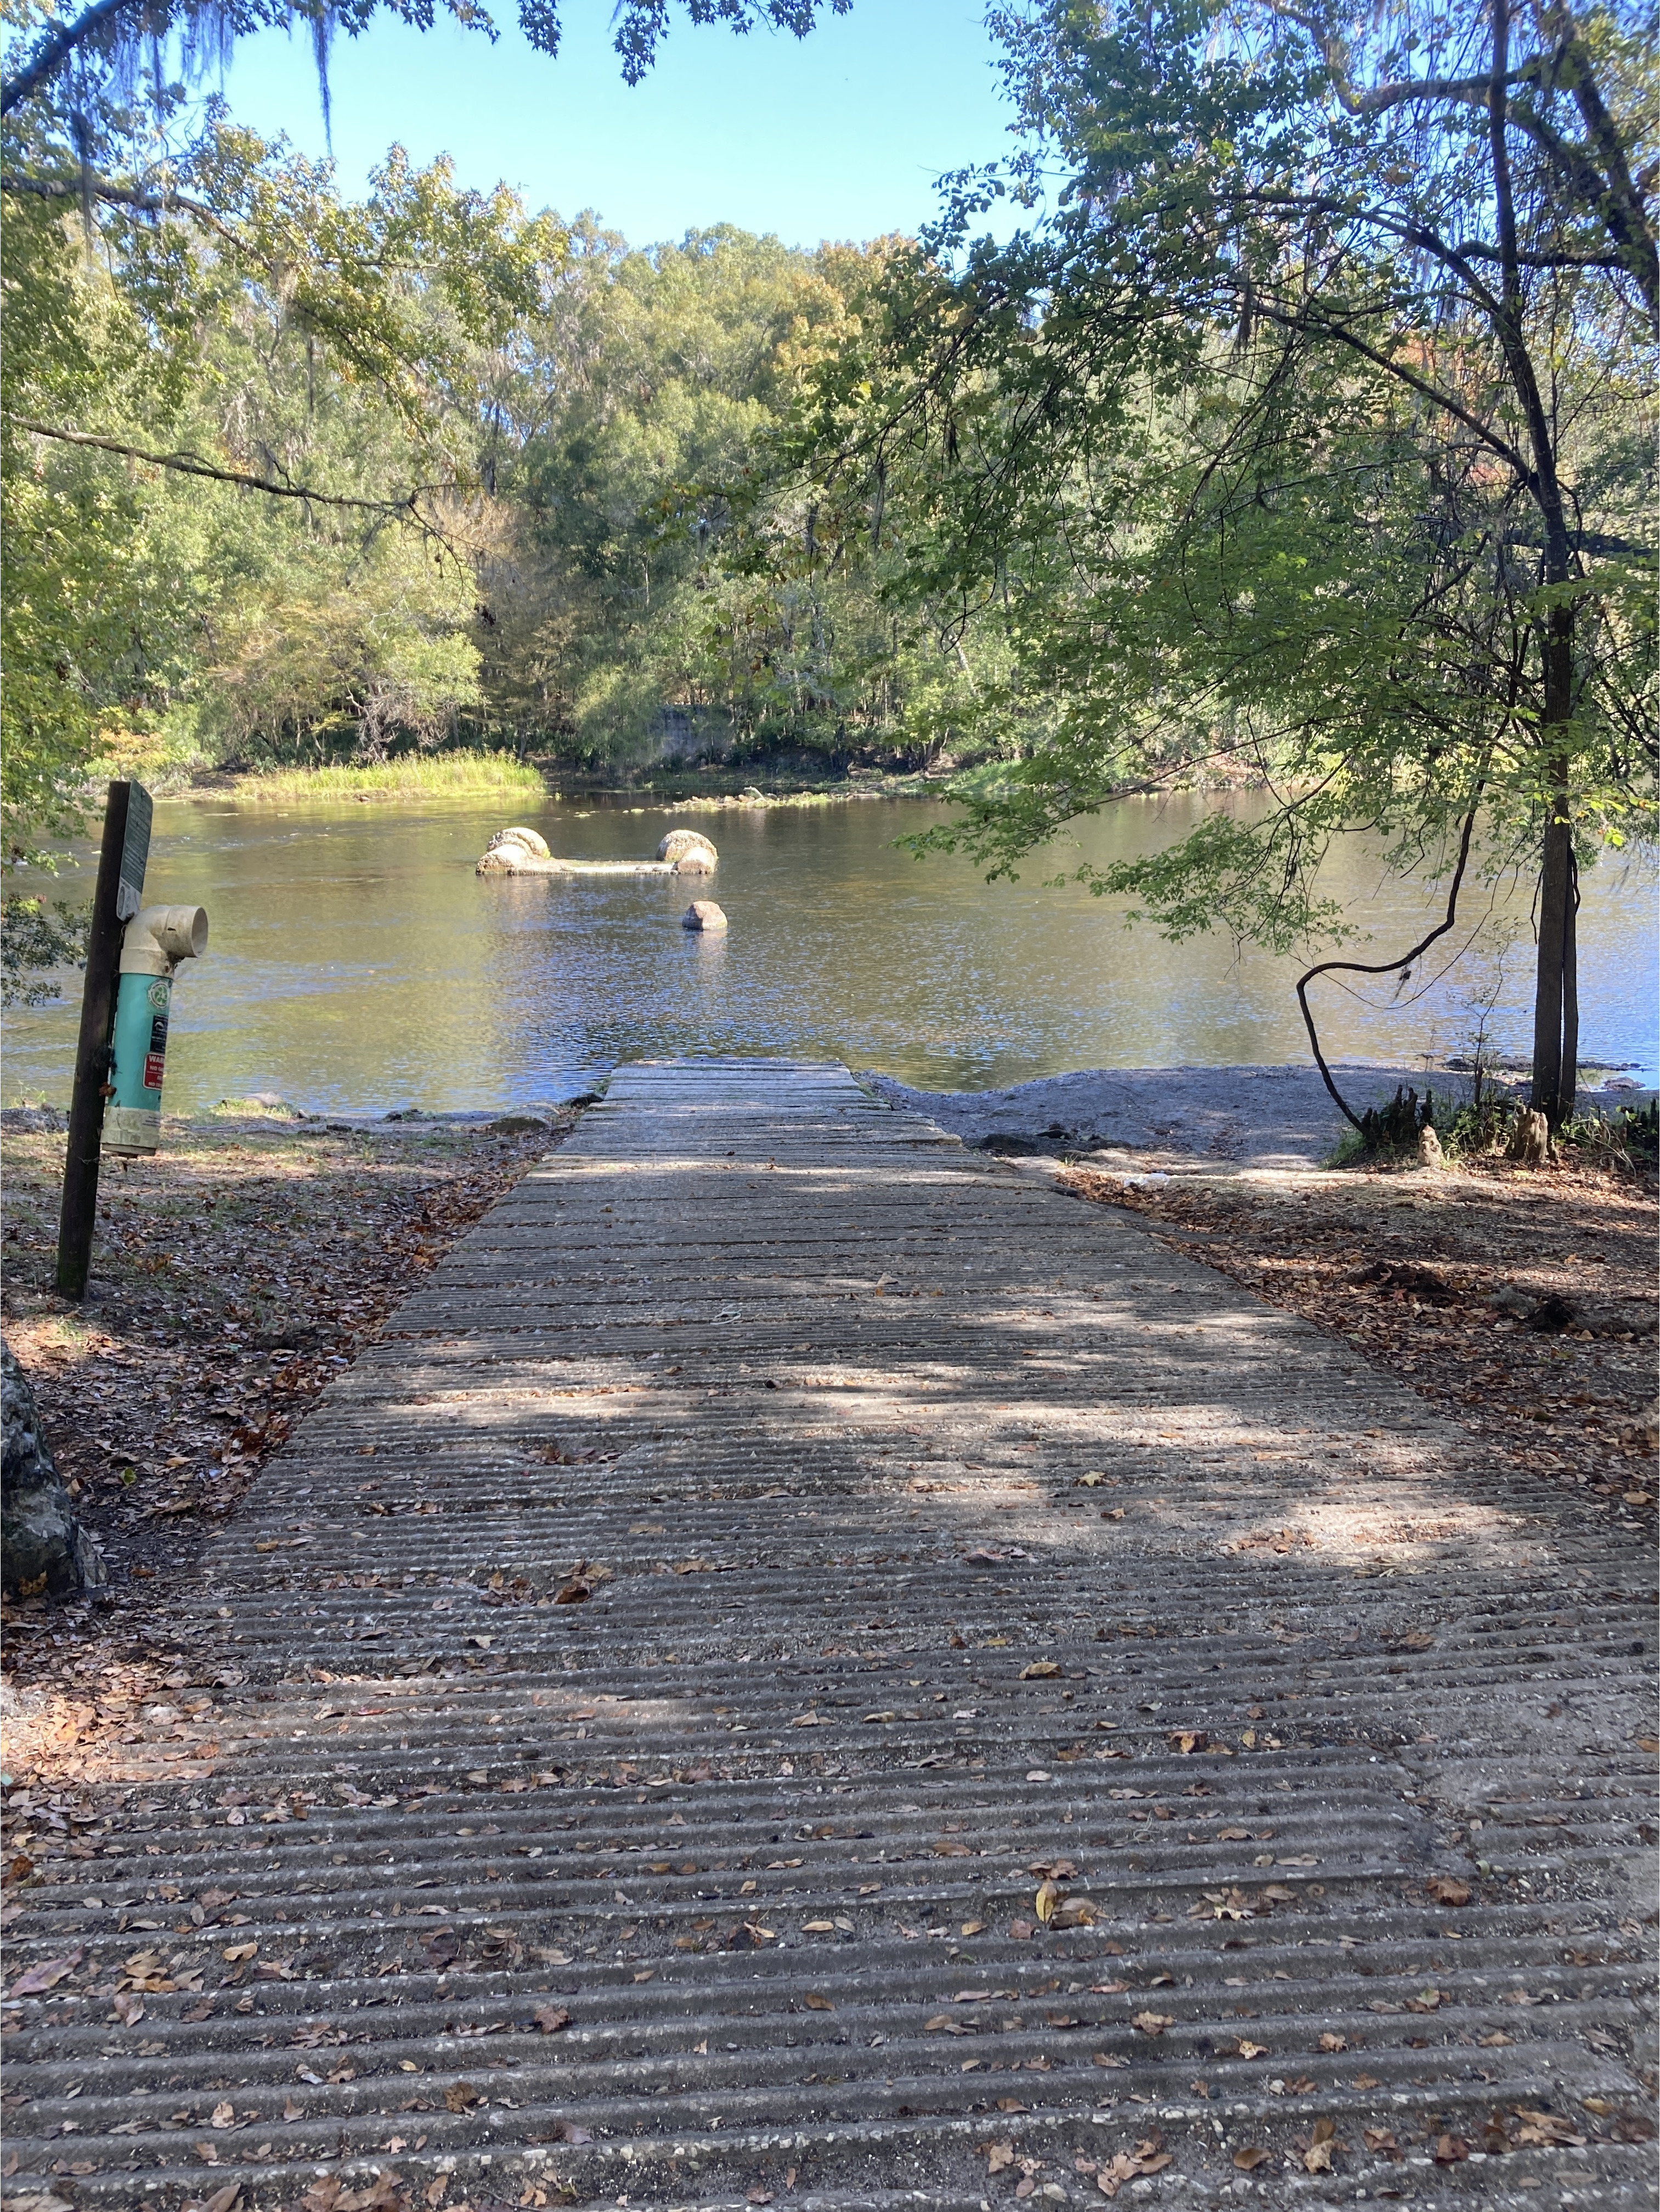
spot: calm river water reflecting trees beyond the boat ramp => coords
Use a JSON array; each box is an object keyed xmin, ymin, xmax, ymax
[{"xmin": 4, "ymin": 799, "xmax": 1656, "ymax": 1113}]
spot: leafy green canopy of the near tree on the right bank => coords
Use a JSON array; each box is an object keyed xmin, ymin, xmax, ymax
[{"xmin": 797, "ymin": 0, "xmax": 1656, "ymax": 1022}]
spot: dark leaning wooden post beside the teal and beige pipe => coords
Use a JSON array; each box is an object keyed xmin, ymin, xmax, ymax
[{"xmin": 58, "ymin": 783, "xmax": 150, "ymax": 1299}]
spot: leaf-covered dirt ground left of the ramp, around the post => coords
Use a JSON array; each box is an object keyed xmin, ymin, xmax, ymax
[{"xmin": 0, "ymin": 1108, "xmax": 575, "ymax": 1725}]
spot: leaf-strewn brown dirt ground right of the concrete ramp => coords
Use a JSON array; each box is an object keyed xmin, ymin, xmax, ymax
[{"xmin": 1060, "ymin": 1159, "xmax": 1658, "ymax": 1537}]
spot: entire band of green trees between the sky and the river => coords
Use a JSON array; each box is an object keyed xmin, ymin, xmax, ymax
[{"xmin": 0, "ymin": 0, "xmax": 1660, "ymax": 1119}]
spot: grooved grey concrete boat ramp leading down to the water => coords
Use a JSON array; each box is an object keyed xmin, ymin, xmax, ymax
[{"xmin": 7, "ymin": 1062, "xmax": 1653, "ymax": 2212}]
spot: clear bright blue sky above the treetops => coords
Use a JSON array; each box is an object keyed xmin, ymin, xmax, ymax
[{"xmin": 226, "ymin": 0, "xmax": 1027, "ymax": 246}]
